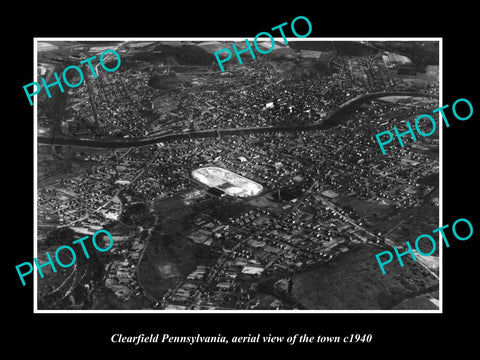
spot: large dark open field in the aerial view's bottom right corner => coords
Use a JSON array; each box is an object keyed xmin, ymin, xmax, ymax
[{"xmin": 292, "ymin": 245, "xmax": 438, "ymax": 310}]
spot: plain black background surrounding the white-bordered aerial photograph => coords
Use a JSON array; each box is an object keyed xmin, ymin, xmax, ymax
[{"xmin": 6, "ymin": 2, "xmax": 480, "ymax": 358}]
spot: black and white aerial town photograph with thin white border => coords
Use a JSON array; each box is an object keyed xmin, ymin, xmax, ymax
[{"xmin": 33, "ymin": 38, "xmax": 440, "ymax": 312}]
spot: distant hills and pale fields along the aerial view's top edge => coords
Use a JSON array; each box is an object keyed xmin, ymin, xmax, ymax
[{"xmin": 36, "ymin": 38, "xmax": 439, "ymax": 77}]
